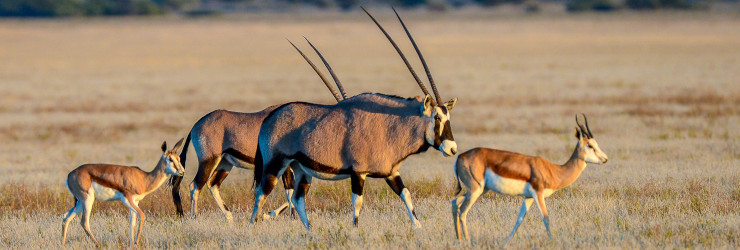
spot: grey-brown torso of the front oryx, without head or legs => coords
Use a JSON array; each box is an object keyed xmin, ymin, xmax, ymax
[{"xmin": 259, "ymin": 93, "xmax": 428, "ymax": 179}]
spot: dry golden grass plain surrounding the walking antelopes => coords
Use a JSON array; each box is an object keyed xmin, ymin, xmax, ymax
[{"xmin": 0, "ymin": 10, "xmax": 740, "ymax": 248}]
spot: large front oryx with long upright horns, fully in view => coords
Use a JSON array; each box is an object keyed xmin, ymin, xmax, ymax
[{"xmin": 251, "ymin": 8, "xmax": 457, "ymax": 230}]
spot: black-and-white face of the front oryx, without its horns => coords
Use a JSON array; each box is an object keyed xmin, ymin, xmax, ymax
[{"xmin": 422, "ymin": 95, "xmax": 457, "ymax": 156}]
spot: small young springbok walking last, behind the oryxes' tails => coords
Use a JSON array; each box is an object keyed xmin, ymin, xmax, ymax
[{"xmin": 62, "ymin": 139, "xmax": 185, "ymax": 247}]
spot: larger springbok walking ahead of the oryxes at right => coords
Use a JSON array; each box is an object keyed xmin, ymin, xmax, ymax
[{"xmin": 452, "ymin": 115, "xmax": 608, "ymax": 244}]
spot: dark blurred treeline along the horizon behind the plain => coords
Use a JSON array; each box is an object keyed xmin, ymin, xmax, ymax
[{"xmin": 0, "ymin": 0, "xmax": 724, "ymax": 17}]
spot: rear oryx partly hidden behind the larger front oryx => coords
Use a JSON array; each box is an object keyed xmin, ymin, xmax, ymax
[{"xmin": 170, "ymin": 39, "xmax": 347, "ymax": 221}]
